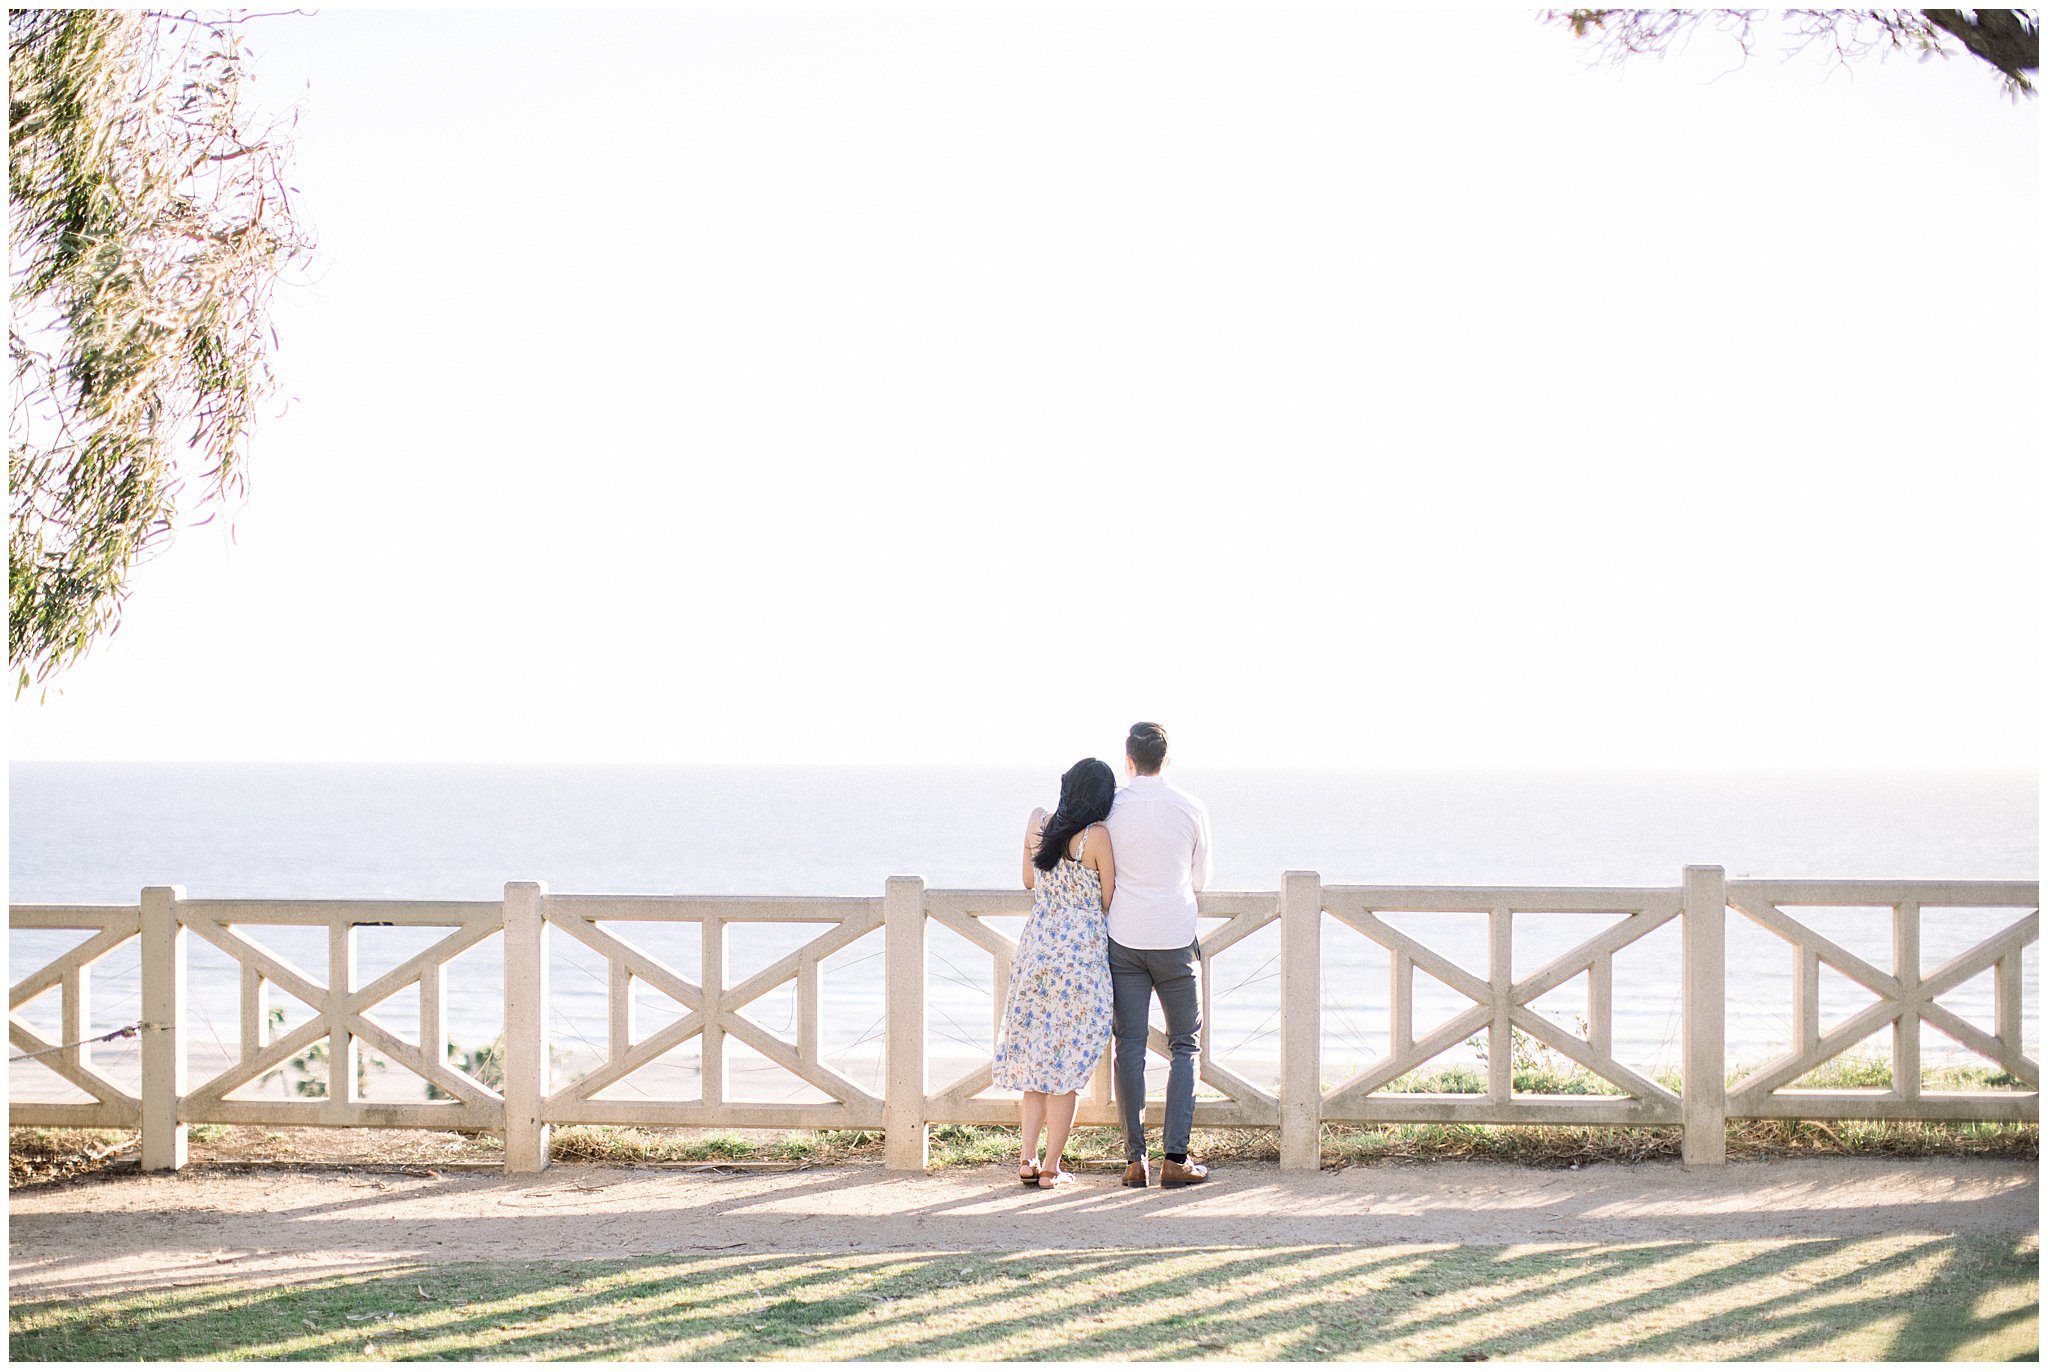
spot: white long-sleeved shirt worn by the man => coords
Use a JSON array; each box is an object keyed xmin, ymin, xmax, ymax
[{"xmin": 1108, "ymin": 777, "xmax": 1208, "ymax": 949}]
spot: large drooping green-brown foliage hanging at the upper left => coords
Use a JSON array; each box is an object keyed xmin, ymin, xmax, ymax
[{"xmin": 8, "ymin": 10, "xmax": 309, "ymax": 695}]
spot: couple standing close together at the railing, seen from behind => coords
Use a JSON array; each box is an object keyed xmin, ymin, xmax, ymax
[{"xmin": 995, "ymin": 723, "xmax": 1208, "ymax": 1189}]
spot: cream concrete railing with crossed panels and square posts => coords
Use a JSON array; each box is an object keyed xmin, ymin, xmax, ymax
[{"xmin": 8, "ymin": 867, "xmax": 2040, "ymax": 1172}]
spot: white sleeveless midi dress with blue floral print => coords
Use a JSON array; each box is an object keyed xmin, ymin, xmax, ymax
[{"xmin": 995, "ymin": 823, "xmax": 1112, "ymax": 1094}]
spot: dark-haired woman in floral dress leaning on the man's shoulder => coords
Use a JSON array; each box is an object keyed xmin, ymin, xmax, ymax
[{"xmin": 995, "ymin": 756, "xmax": 1116, "ymax": 1191}]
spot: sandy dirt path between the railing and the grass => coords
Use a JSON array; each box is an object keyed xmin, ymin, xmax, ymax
[{"xmin": 8, "ymin": 1158, "xmax": 2040, "ymax": 1299}]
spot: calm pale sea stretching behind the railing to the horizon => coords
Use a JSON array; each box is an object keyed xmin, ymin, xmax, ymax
[{"xmin": 8, "ymin": 762, "xmax": 2040, "ymax": 1098}]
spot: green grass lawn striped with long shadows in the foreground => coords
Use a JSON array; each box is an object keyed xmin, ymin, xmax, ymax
[{"xmin": 8, "ymin": 1236, "xmax": 2040, "ymax": 1361}]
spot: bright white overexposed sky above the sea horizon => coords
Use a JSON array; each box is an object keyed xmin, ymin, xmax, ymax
[{"xmin": 10, "ymin": 8, "xmax": 2042, "ymax": 766}]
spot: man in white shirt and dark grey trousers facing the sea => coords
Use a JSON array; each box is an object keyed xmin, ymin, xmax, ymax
[{"xmin": 1108, "ymin": 723, "xmax": 1208, "ymax": 1187}]
